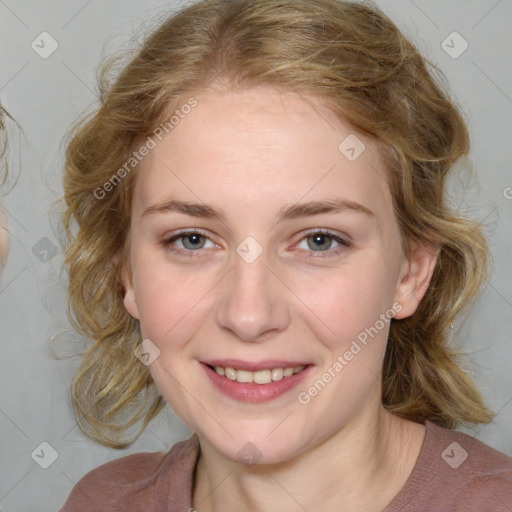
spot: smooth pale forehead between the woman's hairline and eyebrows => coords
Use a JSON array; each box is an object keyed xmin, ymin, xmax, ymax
[{"xmin": 134, "ymin": 87, "xmax": 390, "ymax": 220}]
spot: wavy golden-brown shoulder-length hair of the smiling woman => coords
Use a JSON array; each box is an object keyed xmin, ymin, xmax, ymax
[{"xmin": 59, "ymin": 0, "xmax": 492, "ymax": 448}]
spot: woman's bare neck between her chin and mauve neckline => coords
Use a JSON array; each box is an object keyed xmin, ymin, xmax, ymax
[{"xmin": 193, "ymin": 405, "xmax": 425, "ymax": 512}]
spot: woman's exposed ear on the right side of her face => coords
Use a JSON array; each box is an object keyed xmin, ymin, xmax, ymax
[{"xmin": 395, "ymin": 244, "xmax": 439, "ymax": 319}]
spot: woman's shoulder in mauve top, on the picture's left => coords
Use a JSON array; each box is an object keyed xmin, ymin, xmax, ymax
[{"xmin": 60, "ymin": 437, "xmax": 197, "ymax": 512}]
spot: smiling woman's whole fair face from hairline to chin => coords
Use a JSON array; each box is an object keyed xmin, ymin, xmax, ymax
[{"xmin": 123, "ymin": 88, "xmax": 431, "ymax": 463}]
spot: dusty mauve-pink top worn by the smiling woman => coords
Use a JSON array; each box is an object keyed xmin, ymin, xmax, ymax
[{"xmin": 60, "ymin": 421, "xmax": 512, "ymax": 512}]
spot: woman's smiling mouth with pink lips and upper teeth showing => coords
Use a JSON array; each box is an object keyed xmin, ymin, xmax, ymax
[{"xmin": 201, "ymin": 361, "xmax": 313, "ymax": 403}]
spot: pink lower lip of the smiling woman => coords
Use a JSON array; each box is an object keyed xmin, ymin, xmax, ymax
[{"xmin": 201, "ymin": 363, "xmax": 312, "ymax": 403}]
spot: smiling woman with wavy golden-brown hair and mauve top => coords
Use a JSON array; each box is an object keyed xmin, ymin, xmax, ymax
[{"xmin": 62, "ymin": 0, "xmax": 512, "ymax": 512}]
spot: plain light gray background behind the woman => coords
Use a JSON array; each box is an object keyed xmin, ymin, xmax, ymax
[{"xmin": 0, "ymin": 0, "xmax": 512, "ymax": 512}]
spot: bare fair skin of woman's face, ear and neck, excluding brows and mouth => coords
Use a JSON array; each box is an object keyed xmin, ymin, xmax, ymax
[{"xmin": 122, "ymin": 87, "xmax": 436, "ymax": 512}]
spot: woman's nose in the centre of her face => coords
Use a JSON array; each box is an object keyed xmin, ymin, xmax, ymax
[{"xmin": 216, "ymin": 246, "xmax": 291, "ymax": 342}]
